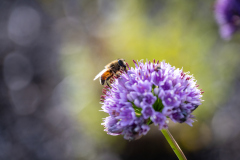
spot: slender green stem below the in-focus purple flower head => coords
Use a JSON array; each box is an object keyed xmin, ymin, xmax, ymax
[{"xmin": 161, "ymin": 129, "xmax": 187, "ymax": 160}]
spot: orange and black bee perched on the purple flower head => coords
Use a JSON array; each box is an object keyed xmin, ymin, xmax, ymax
[{"xmin": 93, "ymin": 59, "xmax": 127, "ymax": 87}]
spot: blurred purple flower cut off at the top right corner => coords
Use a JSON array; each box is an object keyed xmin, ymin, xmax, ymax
[{"xmin": 215, "ymin": 0, "xmax": 240, "ymax": 40}]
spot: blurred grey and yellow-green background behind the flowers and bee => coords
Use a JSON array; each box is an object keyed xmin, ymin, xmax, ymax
[{"xmin": 0, "ymin": 0, "xmax": 240, "ymax": 160}]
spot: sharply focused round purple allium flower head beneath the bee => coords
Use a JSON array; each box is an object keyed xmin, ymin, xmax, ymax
[{"xmin": 101, "ymin": 60, "xmax": 203, "ymax": 140}]
